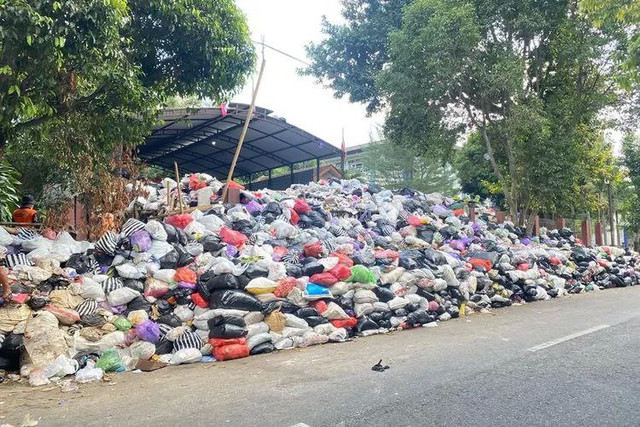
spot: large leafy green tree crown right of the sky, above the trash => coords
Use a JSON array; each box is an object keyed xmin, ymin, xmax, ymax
[{"xmin": 378, "ymin": 0, "xmax": 617, "ymax": 231}]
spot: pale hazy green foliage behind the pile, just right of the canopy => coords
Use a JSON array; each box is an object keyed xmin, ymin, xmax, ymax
[{"xmin": 361, "ymin": 141, "xmax": 460, "ymax": 196}]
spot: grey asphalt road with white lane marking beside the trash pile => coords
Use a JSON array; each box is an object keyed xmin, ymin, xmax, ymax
[{"xmin": 0, "ymin": 287, "xmax": 640, "ymax": 427}]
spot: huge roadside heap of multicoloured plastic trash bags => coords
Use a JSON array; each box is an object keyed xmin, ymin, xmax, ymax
[{"xmin": 0, "ymin": 174, "xmax": 640, "ymax": 385}]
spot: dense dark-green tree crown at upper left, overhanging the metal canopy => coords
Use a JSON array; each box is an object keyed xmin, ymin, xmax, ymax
[{"xmin": 0, "ymin": 0, "xmax": 254, "ymax": 149}]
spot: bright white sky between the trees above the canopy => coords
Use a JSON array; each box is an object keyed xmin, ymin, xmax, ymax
[{"xmin": 233, "ymin": 0, "xmax": 383, "ymax": 147}]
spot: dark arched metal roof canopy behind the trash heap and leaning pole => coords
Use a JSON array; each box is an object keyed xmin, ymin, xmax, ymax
[{"xmin": 139, "ymin": 104, "xmax": 341, "ymax": 180}]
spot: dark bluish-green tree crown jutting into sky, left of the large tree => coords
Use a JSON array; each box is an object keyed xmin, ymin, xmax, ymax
[{"xmin": 302, "ymin": 0, "xmax": 411, "ymax": 113}]
